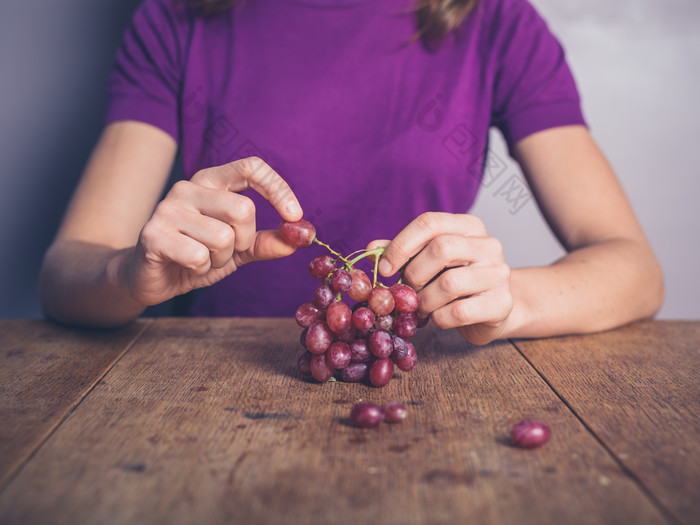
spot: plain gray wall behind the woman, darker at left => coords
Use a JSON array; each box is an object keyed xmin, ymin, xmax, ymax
[{"xmin": 0, "ymin": 0, "xmax": 700, "ymax": 319}]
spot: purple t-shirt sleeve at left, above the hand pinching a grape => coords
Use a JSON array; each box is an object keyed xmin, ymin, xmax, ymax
[{"xmin": 105, "ymin": 0, "xmax": 187, "ymax": 141}]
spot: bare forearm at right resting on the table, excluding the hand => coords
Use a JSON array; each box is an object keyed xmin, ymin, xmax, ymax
[{"xmin": 504, "ymin": 239, "xmax": 664, "ymax": 337}]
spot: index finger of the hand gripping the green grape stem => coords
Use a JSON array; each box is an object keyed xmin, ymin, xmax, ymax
[{"xmin": 379, "ymin": 212, "xmax": 486, "ymax": 277}]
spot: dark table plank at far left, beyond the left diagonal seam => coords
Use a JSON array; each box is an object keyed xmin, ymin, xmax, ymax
[{"xmin": 0, "ymin": 320, "xmax": 147, "ymax": 489}]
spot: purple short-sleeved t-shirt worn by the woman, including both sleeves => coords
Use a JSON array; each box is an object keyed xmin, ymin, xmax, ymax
[{"xmin": 106, "ymin": 0, "xmax": 584, "ymax": 317}]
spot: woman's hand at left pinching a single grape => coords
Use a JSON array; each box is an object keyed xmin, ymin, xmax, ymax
[{"xmin": 114, "ymin": 157, "xmax": 302, "ymax": 305}]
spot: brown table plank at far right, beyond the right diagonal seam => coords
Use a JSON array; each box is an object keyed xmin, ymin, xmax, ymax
[{"xmin": 516, "ymin": 321, "xmax": 700, "ymax": 524}]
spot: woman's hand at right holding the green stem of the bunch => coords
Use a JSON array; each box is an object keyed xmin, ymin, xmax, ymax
[{"xmin": 370, "ymin": 212, "xmax": 513, "ymax": 345}]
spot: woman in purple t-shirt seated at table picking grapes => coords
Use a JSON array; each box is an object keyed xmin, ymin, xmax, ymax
[{"xmin": 41, "ymin": 0, "xmax": 663, "ymax": 344}]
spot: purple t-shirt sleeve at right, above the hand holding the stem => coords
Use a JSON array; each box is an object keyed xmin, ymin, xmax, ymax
[{"xmin": 491, "ymin": 0, "xmax": 586, "ymax": 148}]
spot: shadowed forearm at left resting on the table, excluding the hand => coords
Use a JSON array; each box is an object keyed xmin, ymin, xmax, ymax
[{"xmin": 39, "ymin": 241, "xmax": 145, "ymax": 328}]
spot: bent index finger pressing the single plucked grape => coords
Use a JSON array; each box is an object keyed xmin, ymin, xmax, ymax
[{"xmin": 191, "ymin": 157, "xmax": 303, "ymax": 222}]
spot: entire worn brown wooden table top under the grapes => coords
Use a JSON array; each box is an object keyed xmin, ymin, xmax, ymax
[{"xmin": 0, "ymin": 319, "xmax": 700, "ymax": 525}]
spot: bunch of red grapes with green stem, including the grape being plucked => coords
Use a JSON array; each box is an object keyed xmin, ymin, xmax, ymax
[{"xmin": 280, "ymin": 219, "xmax": 427, "ymax": 388}]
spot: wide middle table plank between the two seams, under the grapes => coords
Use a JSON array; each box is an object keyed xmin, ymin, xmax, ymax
[{"xmin": 0, "ymin": 319, "xmax": 667, "ymax": 525}]
